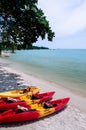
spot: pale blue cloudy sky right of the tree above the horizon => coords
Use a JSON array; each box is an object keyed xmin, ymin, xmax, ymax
[{"xmin": 35, "ymin": 0, "xmax": 86, "ymax": 49}]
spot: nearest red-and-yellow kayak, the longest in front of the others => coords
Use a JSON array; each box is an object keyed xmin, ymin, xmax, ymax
[{"xmin": 0, "ymin": 98, "xmax": 70, "ymax": 123}]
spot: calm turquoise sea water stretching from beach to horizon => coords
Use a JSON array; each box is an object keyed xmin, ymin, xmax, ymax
[{"xmin": 1, "ymin": 49, "xmax": 86, "ymax": 95}]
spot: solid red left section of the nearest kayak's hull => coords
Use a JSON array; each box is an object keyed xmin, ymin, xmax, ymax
[{"xmin": 0, "ymin": 109, "xmax": 39, "ymax": 123}]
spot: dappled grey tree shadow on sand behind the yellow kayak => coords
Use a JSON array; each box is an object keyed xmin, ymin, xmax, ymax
[{"xmin": 0, "ymin": 66, "xmax": 27, "ymax": 92}]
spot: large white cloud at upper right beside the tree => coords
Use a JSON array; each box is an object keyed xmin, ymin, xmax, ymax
[{"xmin": 39, "ymin": 0, "xmax": 86, "ymax": 37}]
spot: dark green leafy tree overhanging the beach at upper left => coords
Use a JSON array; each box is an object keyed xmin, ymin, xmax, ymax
[{"xmin": 0, "ymin": 0, "xmax": 55, "ymax": 53}]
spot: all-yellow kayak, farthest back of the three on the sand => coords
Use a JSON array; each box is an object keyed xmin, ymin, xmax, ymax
[{"xmin": 0, "ymin": 86, "xmax": 40, "ymax": 98}]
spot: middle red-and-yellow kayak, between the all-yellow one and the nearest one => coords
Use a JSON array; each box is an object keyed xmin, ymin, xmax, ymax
[{"xmin": 0, "ymin": 91, "xmax": 55, "ymax": 111}]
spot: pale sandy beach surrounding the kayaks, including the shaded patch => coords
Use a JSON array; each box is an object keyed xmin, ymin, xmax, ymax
[{"xmin": 0, "ymin": 59, "xmax": 86, "ymax": 130}]
